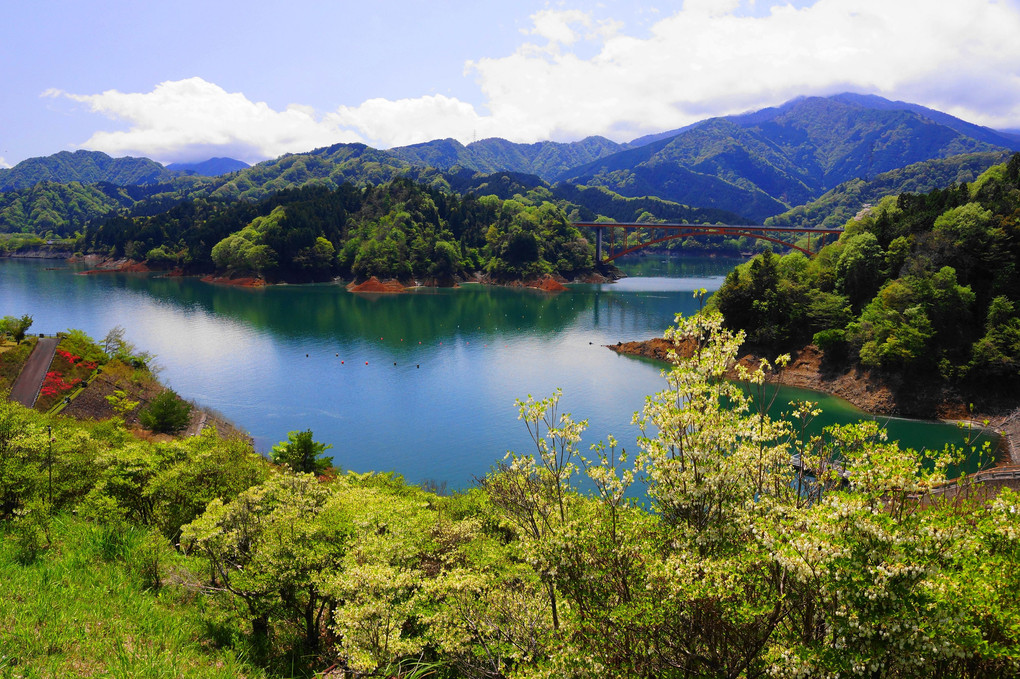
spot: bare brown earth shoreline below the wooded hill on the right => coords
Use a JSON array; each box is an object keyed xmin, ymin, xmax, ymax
[{"xmin": 607, "ymin": 337, "xmax": 1020, "ymax": 467}]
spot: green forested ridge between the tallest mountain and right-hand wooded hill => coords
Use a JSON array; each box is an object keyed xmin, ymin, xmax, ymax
[{"xmin": 765, "ymin": 152, "xmax": 1010, "ymax": 227}]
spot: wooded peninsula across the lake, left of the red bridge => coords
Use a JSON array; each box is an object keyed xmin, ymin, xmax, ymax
[{"xmin": 80, "ymin": 178, "xmax": 595, "ymax": 281}]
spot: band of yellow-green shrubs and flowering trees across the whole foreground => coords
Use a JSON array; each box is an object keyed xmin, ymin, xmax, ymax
[{"xmin": 0, "ymin": 315, "xmax": 1020, "ymax": 678}]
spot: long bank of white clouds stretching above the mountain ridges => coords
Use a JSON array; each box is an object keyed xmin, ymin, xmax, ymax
[{"xmin": 45, "ymin": 0, "xmax": 1020, "ymax": 160}]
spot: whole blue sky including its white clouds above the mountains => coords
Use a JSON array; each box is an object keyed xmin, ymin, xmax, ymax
[{"xmin": 0, "ymin": 0, "xmax": 1020, "ymax": 166}]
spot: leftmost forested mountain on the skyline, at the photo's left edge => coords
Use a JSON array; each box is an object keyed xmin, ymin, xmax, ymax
[{"xmin": 0, "ymin": 151, "xmax": 176, "ymax": 191}]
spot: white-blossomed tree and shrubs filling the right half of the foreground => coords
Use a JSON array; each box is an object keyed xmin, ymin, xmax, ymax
[{"xmin": 486, "ymin": 314, "xmax": 1020, "ymax": 677}]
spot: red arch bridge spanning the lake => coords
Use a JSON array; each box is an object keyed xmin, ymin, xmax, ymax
[{"xmin": 573, "ymin": 221, "xmax": 843, "ymax": 262}]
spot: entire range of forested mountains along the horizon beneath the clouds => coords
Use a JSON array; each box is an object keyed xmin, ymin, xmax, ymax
[{"xmin": 0, "ymin": 94, "xmax": 1020, "ymax": 230}]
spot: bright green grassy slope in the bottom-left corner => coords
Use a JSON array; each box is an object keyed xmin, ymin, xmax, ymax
[{"xmin": 0, "ymin": 516, "xmax": 266, "ymax": 679}]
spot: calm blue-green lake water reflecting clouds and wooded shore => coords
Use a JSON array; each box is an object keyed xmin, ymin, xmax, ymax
[{"xmin": 0, "ymin": 258, "xmax": 987, "ymax": 488}]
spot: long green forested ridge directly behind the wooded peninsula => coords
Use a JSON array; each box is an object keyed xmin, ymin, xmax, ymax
[{"xmin": 0, "ymin": 152, "xmax": 741, "ymax": 237}]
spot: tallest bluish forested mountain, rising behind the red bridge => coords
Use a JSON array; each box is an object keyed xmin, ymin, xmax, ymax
[{"xmin": 560, "ymin": 95, "xmax": 1020, "ymax": 221}]
